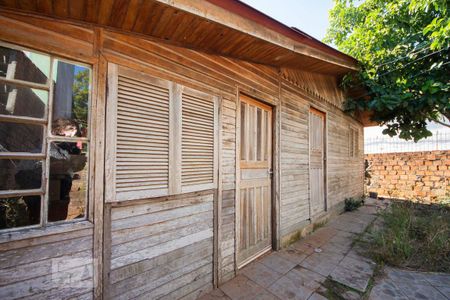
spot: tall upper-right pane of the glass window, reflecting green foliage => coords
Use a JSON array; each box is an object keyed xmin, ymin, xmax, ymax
[{"xmin": 52, "ymin": 61, "xmax": 91, "ymax": 137}]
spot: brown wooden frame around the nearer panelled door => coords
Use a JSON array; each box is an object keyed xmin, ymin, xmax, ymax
[{"xmin": 234, "ymin": 91, "xmax": 280, "ymax": 272}]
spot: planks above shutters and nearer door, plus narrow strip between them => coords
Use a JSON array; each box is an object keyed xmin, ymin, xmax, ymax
[{"xmin": 100, "ymin": 28, "xmax": 279, "ymax": 290}]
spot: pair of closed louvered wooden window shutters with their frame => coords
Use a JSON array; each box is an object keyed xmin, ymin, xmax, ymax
[{"xmin": 105, "ymin": 64, "xmax": 218, "ymax": 202}]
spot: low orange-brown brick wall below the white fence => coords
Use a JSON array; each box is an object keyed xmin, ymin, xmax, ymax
[{"xmin": 365, "ymin": 151, "xmax": 450, "ymax": 202}]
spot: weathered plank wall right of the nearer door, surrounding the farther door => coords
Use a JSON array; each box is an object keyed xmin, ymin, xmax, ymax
[{"xmin": 280, "ymin": 79, "xmax": 364, "ymax": 239}]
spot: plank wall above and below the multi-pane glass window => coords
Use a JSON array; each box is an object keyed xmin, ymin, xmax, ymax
[{"xmin": 0, "ymin": 13, "xmax": 96, "ymax": 299}]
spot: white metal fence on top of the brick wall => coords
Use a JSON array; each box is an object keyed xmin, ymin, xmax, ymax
[{"xmin": 364, "ymin": 132, "xmax": 450, "ymax": 154}]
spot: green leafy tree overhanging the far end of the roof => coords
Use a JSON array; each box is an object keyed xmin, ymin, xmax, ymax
[{"xmin": 325, "ymin": 0, "xmax": 450, "ymax": 141}]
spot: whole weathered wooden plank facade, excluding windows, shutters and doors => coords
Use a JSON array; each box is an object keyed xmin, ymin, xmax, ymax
[{"xmin": 0, "ymin": 12, "xmax": 364, "ymax": 299}]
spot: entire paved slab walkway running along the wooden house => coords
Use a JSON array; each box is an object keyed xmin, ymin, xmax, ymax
[{"xmin": 201, "ymin": 199, "xmax": 450, "ymax": 300}]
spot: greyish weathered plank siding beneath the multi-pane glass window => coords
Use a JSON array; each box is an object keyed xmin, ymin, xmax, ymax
[{"xmin": 0, "ymin": 226, "xmax": 93, "ymax": 300}]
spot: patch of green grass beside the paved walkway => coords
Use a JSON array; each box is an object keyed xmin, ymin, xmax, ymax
[{"xmin": 360, "ymin": 201, "xmax": 450, "ymax": 272}]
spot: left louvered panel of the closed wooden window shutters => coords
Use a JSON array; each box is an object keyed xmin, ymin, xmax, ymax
[{"xmin": 106, "ymin": 65, "xmax": 170, "ymax": 201}]
